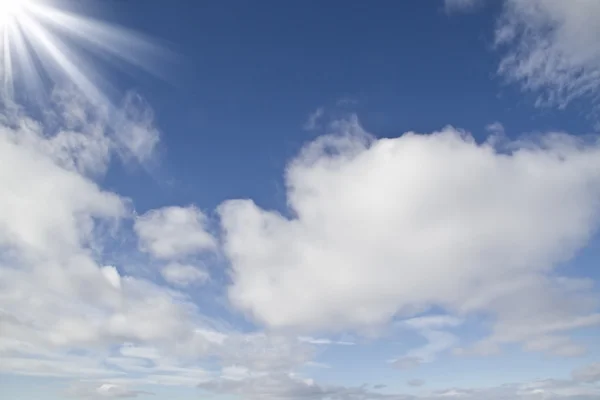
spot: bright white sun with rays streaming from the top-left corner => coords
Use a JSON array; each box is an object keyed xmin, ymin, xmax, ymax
[{"xmin": 0, "ymin": 0, "xmax": 172, "ymax": 103}]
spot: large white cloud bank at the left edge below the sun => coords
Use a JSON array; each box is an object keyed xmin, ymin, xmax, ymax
[{"xmin": 0, "ymin": 87, "xmax": 214, "ymax": 384}]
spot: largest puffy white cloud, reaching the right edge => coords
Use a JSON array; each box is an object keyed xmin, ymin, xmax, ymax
[{"xmin": 219, "ymin": 116, "xmax": 600, "ymax": 354}]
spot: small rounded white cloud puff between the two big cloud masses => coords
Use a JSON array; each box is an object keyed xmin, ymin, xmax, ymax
[{"xmin": 134, "ymin": 206, "xmax": 216, "ymax": 259}]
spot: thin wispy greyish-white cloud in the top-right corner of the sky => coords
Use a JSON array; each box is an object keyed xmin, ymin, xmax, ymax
[{"xmin": 496, "ymin": 0, "xmax": 600, "ymax": 106}]
